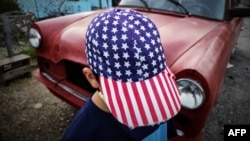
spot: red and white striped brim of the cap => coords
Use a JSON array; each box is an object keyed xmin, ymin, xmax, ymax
[{"xmin": 100, "ymin": 68, "xmax": 181, "ymax": 128}]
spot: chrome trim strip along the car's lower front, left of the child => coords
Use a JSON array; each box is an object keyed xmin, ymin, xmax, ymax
[{"xmin": 41, "ymin": 72, "xmax": 88, "ymax": 101}]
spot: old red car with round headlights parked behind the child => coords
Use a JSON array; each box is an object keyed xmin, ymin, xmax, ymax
[{"xmin": 29, "ymin": 0, "xmax": 250, "ymax": 141}]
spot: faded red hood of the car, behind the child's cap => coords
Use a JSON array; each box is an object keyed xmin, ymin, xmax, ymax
[{"xmin": 43, "ymin": 12, "xmax": 220, "ymax": 65}]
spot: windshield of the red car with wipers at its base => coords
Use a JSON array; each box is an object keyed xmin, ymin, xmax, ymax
[{"xmin": 119, "ymin": 0, "xmax": 226, "ymax": 20}]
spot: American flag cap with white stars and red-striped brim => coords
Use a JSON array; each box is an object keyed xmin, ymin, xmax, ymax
[{"xmin": 85, "ymin": 8, "xmax": 180, "ymax": 128}]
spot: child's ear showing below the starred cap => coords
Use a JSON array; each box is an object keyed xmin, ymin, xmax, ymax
[{"xmin": 82, "ymin": 67, "xmax": 99, "ymax": 89}]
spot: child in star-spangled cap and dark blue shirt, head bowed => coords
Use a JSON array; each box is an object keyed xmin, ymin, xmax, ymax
[{"xmin": 62, "ymin": 9, "xmax": 181, "ymax": 141}]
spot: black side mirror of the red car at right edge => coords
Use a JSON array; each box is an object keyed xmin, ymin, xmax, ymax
[{"xmin": 230, "ymin": 7, "xmax": 250, "ymax": 17}]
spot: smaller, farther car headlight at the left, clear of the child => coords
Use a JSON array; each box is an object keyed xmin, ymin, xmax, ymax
[{"xmin": 29, "ymin": 28, "xmax": 41, "ymax": 48}]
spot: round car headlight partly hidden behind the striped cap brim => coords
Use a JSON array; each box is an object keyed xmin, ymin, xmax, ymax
[{"xmin": 177, "ymin": 79, "xmax": 205, "ymax": 109}]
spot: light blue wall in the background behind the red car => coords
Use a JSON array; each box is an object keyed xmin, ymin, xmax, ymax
[{"xmin": 17, "ymin": 0, "xmax": 112, "ymax": 18}]
